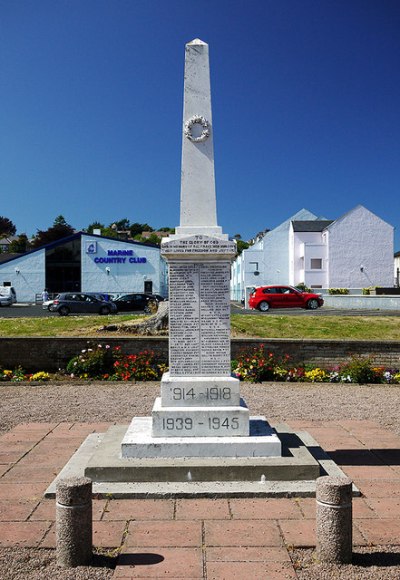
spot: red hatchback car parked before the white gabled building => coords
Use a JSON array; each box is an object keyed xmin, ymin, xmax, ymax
[{"xmin": 249, "ymin": 286, "xmax": 324, "ymax": 312}]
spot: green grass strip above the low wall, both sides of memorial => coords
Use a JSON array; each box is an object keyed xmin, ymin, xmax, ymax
[{"xmin": 0, "ymin": 313, "xmax": 400, "ymax": 340}]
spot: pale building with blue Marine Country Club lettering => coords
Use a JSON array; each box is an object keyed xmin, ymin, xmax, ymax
[{"xmin": 0, "ymin": 232, "xmax": 168, "ymax": 302}]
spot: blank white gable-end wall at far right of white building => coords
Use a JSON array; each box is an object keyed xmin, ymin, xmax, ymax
[{"xmin": 327, "ymin": 206, "xmax": 394, "ymax": 288}]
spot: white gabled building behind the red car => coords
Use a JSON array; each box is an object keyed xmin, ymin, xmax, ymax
[{"xmin": 231, "ymin": 205, "xmax": 394, "ymax": 300}]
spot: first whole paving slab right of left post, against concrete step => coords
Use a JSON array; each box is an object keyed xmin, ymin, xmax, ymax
[{"xmin": 102, "ymin": 499, "xmax": 174, "ymax": 521}]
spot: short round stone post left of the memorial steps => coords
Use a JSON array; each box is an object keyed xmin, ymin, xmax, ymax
[{"xmin": 56, "ymin": 477, "xmax": 92, "ymax": 568}]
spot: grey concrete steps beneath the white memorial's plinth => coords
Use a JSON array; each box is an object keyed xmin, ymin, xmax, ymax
[{"xmin": 45, "ymin": 424, "xmax": 359, "ymax": 498}]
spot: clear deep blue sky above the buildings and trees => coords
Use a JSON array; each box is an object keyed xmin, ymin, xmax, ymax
[{"xmin": 0, "ymin": 0, "xmax": 400, "ymax": 250}]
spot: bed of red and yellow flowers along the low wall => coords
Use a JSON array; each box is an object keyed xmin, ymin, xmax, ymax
[{"xmin": 0, "ymin": 343, "xmax": 400, "ymax": 384}]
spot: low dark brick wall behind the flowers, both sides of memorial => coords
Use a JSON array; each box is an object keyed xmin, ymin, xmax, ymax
[{"xmin": 0, "ymin": 337, "xmax": 400, "ymax": 372}]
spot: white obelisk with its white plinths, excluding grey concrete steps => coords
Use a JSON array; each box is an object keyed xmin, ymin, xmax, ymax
[{"xmin": 121, "ymin": 39, "xmax": 281, "ymax": 458}]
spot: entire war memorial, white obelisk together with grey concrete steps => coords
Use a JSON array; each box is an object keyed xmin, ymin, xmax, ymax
[{"xmin": 45, "ymin": 39, "xmax": 357, "ymax": 498}]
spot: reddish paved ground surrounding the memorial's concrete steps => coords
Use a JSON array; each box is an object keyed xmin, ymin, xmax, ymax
[{"xmin": 0, "ymin": 420, "xmax": 400, "ymax": 580}]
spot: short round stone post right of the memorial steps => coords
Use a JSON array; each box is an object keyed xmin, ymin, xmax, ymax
[{"xmin": 316, "ymin": 476, "xmax": 353, "ymax": 564}]
